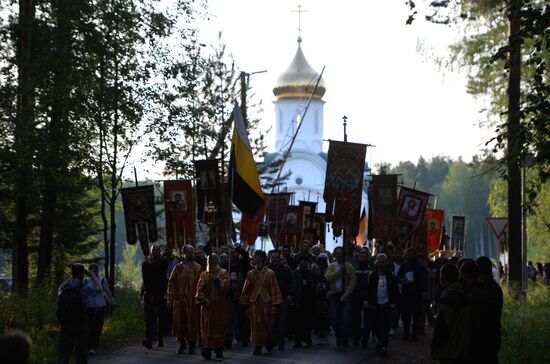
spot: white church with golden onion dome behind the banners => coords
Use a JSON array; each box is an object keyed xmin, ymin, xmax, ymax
[{"xmin": 260, "ymin": 37, "xmax": 368, "ymax": 250}]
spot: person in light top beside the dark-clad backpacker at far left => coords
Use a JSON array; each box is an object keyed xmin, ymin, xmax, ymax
[{"xmin": 84, "ymin": 263, "xmax": 117, "ymax": 356}]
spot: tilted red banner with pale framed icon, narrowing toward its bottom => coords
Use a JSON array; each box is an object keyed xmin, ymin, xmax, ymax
[{"xmin": 397, "ymin": 187, "xmax": 430, "ymax": 246}]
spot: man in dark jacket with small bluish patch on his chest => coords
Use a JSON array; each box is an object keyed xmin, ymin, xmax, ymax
[{"xmin": 397, "ymin": 249, "xmax": 426, "ymax": 341}]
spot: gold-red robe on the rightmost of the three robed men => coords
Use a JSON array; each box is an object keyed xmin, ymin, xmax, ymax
[{"xmin": 240, "ymin": 267, "xmax": 283, "ymax": 346}]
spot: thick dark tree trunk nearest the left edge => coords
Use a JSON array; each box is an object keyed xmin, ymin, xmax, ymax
[{"xmin": 13, "ymin": 0, "xmax": 34, "ymax": 296}]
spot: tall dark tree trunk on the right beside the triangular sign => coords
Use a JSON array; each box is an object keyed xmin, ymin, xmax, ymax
[{"xmin": 506, "ymin": 0, "xmax": 525, "ymax": 288}]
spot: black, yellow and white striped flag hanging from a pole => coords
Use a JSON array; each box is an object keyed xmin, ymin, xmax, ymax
[{"xmin": 229, "ymin": 102, "xmax": 264, "ymax": 217}]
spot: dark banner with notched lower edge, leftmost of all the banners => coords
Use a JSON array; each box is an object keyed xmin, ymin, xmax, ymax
[{"xmin": 121, "ymin": 185, "xmax": 158, "ymax": 256}]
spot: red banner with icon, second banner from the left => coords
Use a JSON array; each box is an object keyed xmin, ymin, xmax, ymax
[{"xmin": 164, "ymin": 180, "xmax": 195, "ymax": 249}]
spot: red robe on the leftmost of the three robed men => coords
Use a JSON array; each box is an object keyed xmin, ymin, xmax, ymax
[{"xmin": 168, "ymin": 262, "xmax": 202, "ymax": 341}]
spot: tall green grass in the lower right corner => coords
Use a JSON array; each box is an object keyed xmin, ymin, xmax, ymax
[{"xmin": 500, "ymin": 285, "xmax": 550, "ymax": 364}]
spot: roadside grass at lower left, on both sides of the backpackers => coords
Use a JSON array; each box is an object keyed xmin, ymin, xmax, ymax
[{"xmin": 0, "ymin": 288, "xmax": 143, "ymax": 363}]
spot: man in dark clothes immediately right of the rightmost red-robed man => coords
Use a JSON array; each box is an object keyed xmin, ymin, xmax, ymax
[{"xmin": 268, "ymin": 250, "xmax": 294, "ymax": 350}]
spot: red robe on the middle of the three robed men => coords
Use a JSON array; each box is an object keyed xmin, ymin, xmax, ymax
[{"xmin": 196, "ymin": 269, "xmax": 230, "ymax": 350}]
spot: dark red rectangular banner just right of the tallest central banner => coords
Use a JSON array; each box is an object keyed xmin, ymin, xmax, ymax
[{"xmin": 370, "ymin": 174, "xmax": 397, "ymax": 242}]
